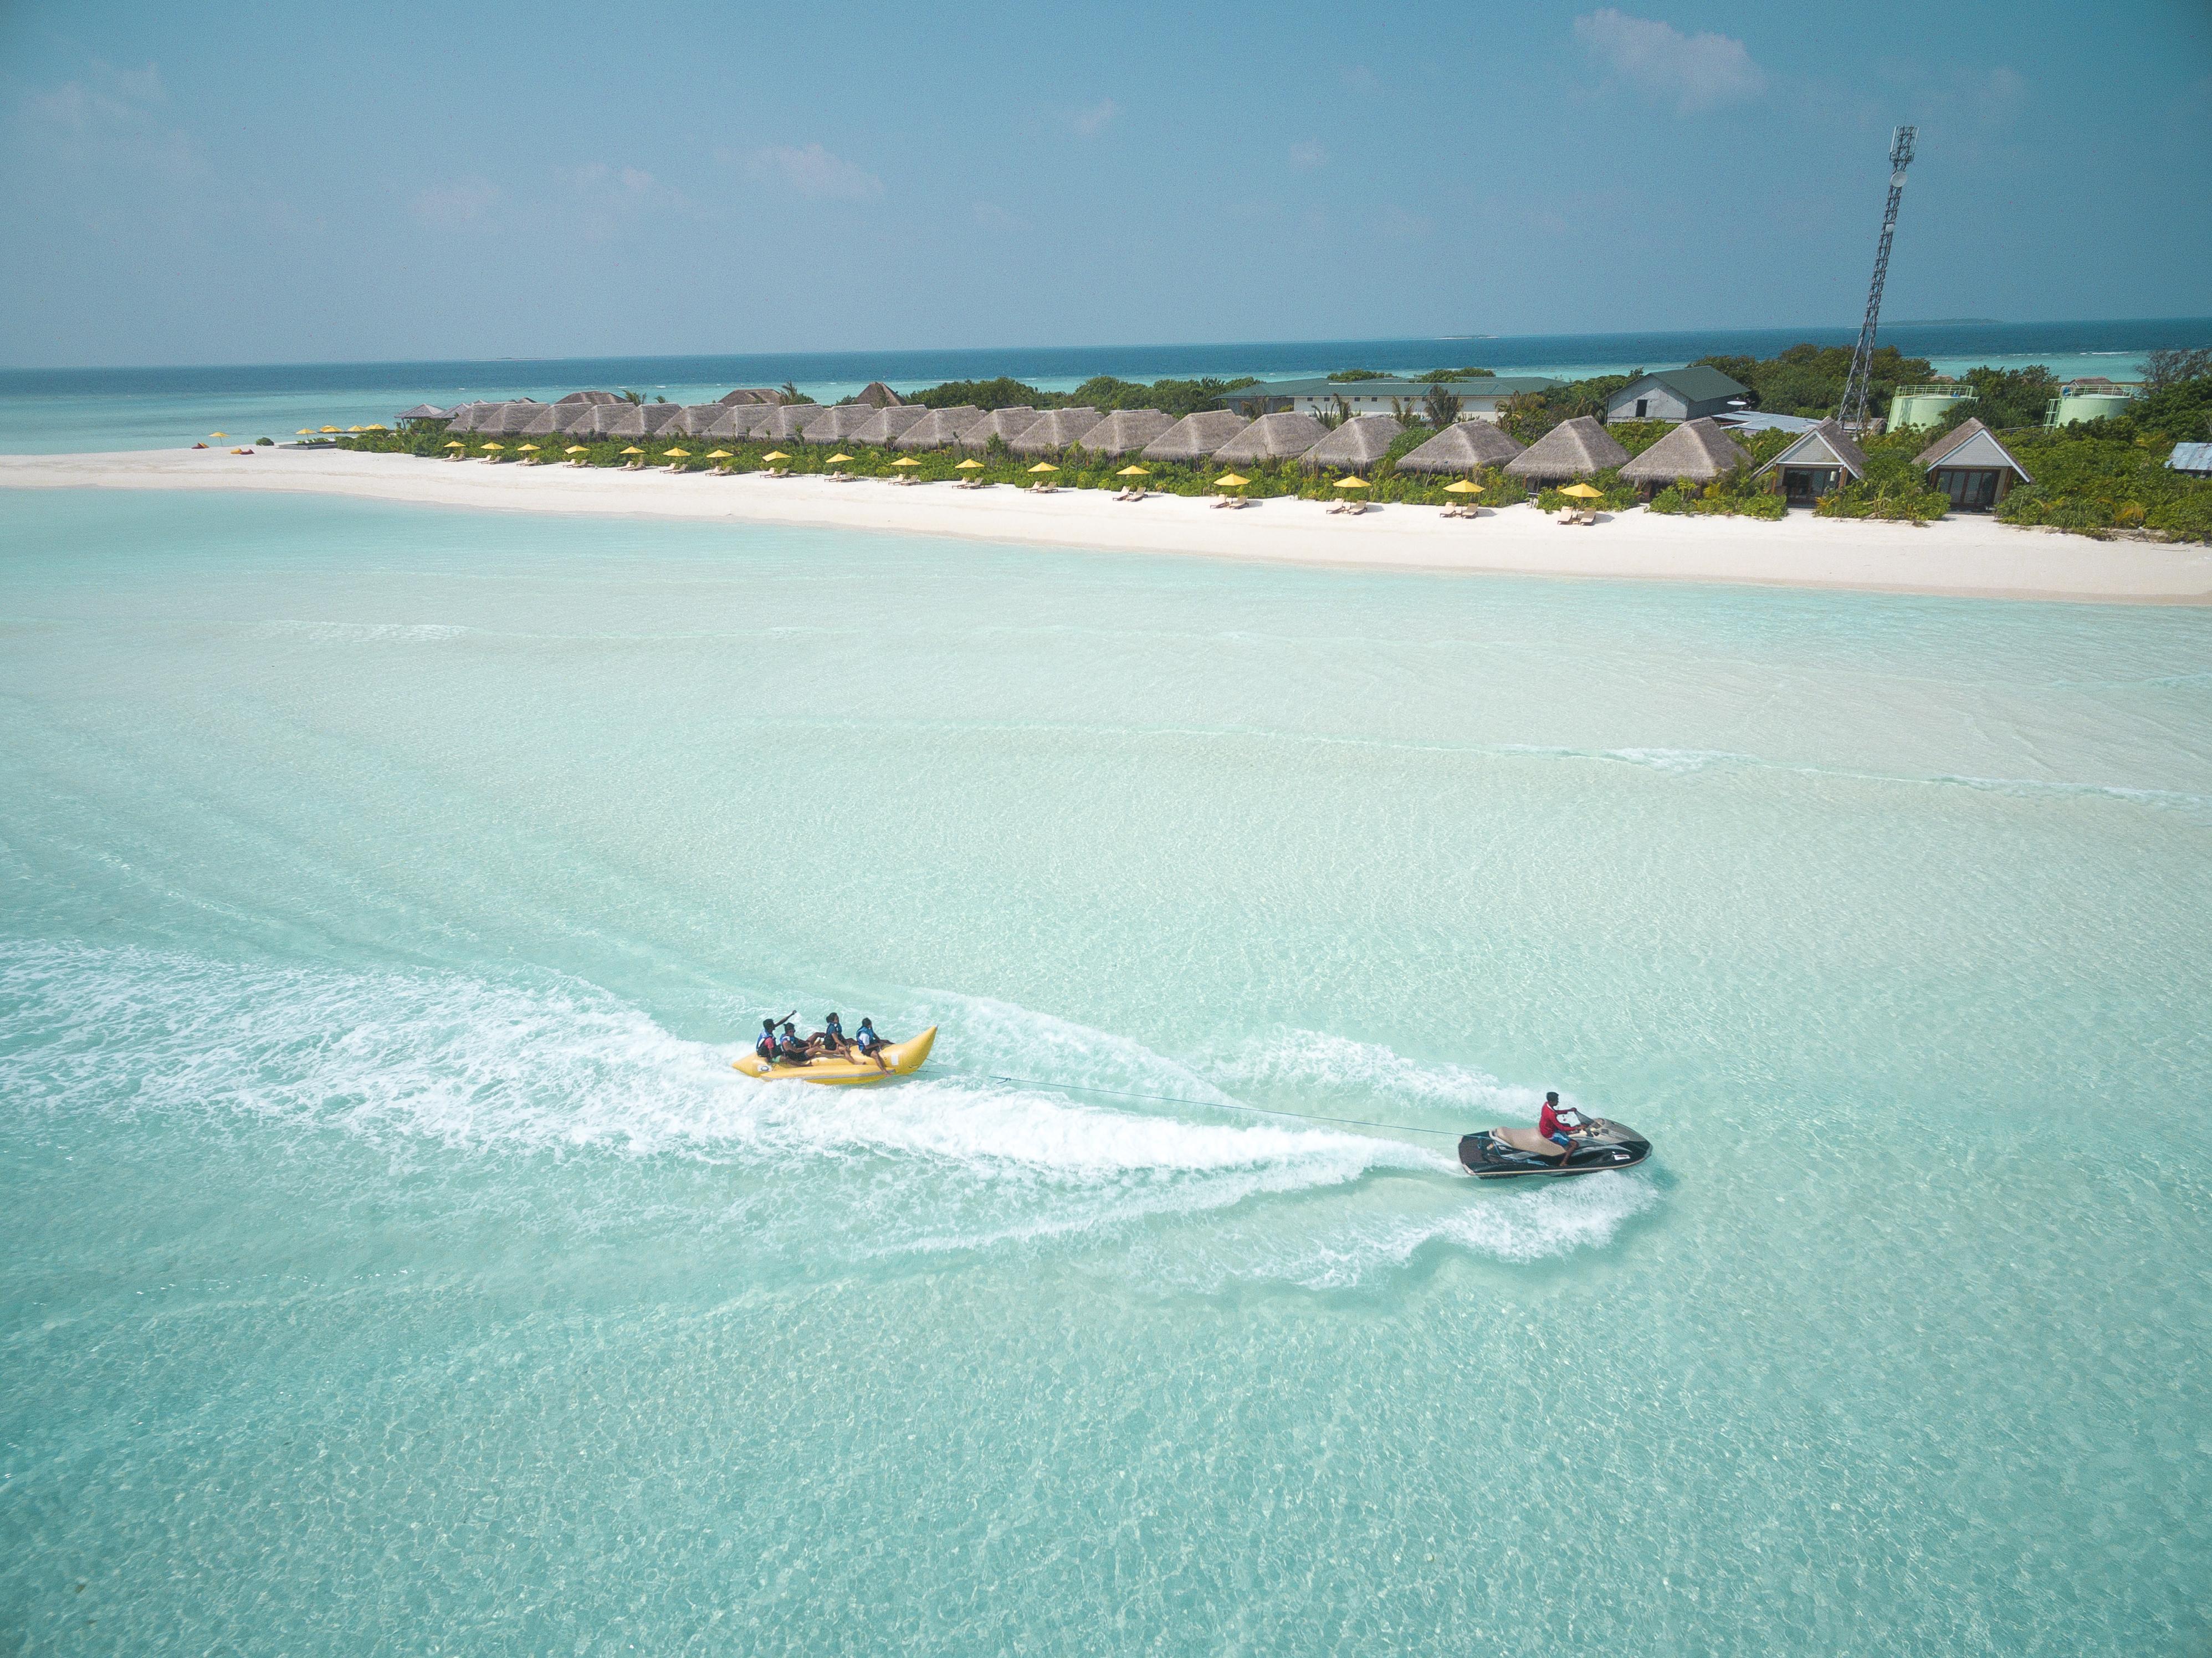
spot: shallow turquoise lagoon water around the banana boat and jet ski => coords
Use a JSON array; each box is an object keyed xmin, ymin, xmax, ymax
[{"xmin": 0, "ymin": 494, "xmax": 2212, "ymax": 1656}]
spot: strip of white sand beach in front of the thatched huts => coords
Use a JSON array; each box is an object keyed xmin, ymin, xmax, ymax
[{"xmin": 0, "ymin": 449, "xmax": 2212, "ymax": 605}]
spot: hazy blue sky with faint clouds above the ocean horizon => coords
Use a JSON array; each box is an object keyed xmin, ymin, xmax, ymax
[{"xmin": 0, "ymin": 0, "xmax": 2212, "ymax": 367}]
